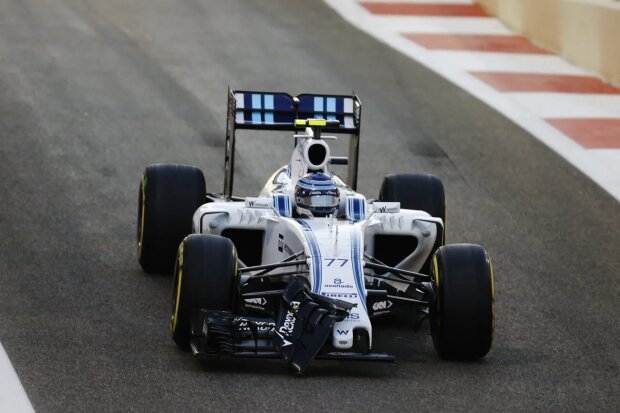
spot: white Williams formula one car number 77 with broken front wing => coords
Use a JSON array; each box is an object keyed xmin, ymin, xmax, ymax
[{"xmin": 137, "ymin": 91, "xmax": 494, "ymax": 373}]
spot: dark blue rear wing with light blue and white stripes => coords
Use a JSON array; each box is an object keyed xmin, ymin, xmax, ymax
[{"xmin": 224, "ymin": 89, "xmax": 362, "ymax": 196}]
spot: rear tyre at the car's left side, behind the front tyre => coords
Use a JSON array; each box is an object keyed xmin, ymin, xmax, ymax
[{"xmin": 137, "ymin": 164, "xmax": 206, "ymax": 274}]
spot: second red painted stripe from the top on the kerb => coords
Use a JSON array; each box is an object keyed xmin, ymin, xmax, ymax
[{"xmin": 404, "ymin": 33, "xmax": 548, "ymax": 54}]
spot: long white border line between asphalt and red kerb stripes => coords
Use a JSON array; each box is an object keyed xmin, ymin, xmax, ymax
[{"xmin": 324, "ymin": 0, "xmax": 620, "ymax": 201}]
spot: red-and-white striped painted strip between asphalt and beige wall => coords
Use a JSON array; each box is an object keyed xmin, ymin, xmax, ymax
[{"xmin": 324, "ymin": 0, "xmax": 620, "ymax": 201}]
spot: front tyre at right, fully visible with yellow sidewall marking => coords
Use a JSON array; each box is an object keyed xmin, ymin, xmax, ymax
[{"xmin": 430, "ymin": 244, "xmax": 495, "ymax": 360}]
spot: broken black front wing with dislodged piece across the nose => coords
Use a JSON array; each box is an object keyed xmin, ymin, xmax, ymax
[{"xmin": 186, "ymin": 278, "xmax": 395, "ymax": 374}]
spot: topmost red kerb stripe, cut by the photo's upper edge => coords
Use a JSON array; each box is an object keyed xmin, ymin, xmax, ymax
[{"xmin": 360, "ymin": 2, "xmax": 489, "ymax": 17}]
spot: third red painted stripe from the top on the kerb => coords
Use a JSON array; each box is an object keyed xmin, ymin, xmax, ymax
[{"xmin": 470, "ymin": 72, "xmax": 620, "ymax": 94}]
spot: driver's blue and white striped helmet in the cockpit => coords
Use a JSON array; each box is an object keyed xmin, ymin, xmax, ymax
[{"xmin": 295, "ymin": 173, "xmax": 340, "ymax": 217}]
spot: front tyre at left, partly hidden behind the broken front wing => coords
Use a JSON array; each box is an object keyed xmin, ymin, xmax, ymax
[{"xmin": 170, "ymin": 234, "xmax": 237, "ymax": 350}]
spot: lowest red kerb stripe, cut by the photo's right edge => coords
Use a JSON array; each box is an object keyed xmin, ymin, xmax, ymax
[{"xmin": 546, "ymin": 119, "xmax": 620, "ymax": 149}]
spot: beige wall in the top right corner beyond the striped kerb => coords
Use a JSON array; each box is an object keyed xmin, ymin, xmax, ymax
[{"xmin": 477, "ymin": 0, "xmax": 620, "ymax": 87}]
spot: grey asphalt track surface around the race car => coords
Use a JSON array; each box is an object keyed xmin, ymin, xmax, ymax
[{"xmin": 0, "ymin": 0, "xmax": 620, "ymax": 412}]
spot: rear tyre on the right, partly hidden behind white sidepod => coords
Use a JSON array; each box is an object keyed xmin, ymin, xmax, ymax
[{"xmin": 379, "ymin": 174, "xmax": 446, "ymax": 274}]
